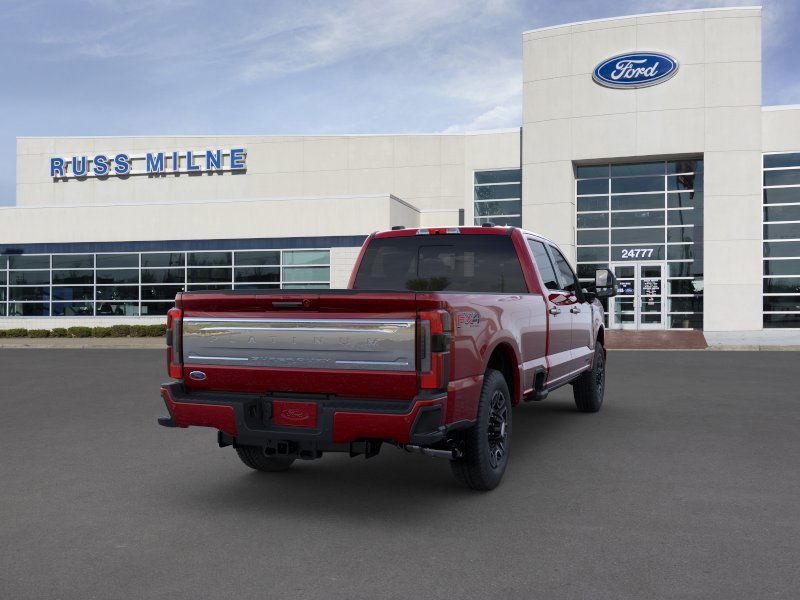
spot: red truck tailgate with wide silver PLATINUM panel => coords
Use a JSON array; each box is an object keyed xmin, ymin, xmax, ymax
[{"xmin": 178, "ymin": 290, "xmax": 434, "ymax": 400}]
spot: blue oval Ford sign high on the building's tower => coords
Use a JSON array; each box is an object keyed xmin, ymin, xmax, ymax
[{"xmin": 592, "ymin": 52, "xmax": 678, "ymax": 88}]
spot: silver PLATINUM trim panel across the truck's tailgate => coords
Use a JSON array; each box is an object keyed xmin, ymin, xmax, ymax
[{"xmin": 183, "ymin": 317, "xmax": 416, "ymax": 371}]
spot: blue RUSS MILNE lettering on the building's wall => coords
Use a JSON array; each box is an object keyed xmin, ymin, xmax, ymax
[{"xmin": 50, "ymin": 148, "xmax": 247, "ymax": 179}]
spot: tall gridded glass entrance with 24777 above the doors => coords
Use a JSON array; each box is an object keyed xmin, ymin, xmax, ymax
[{"xmin": 575, "ymin": 159, "xmax": 703, "ymax": 328}]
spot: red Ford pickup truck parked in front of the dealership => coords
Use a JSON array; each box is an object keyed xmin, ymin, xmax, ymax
[{"xmin": 159, "ymin": 226, "xmax": 616, "ymax": 490}]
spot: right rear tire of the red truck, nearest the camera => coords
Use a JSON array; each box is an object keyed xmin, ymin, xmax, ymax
[{"xmin": 450, "ymin": 369, "xmax": 511, "ymax": 491}]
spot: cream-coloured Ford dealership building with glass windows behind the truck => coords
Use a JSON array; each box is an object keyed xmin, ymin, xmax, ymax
[{"xmin": 0, "ymin": 7, "xmax": 800, "ymax": 333}]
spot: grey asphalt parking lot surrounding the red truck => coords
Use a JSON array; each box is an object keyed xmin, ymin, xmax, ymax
[{"xmin": 0, "ymin": 349, "xmax": 800, "ymax": 600}]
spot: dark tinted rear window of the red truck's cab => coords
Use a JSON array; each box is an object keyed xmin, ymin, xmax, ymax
[{"xmin": 354, "ymin": 234, "xmax": 528, "ymax": 294}]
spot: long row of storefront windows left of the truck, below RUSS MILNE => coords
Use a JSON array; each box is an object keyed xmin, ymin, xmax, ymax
[{"xmin": 0, "ymin": 247, "xmax": 332, "ymax": 317}]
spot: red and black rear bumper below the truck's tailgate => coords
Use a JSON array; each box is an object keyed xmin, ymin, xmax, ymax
[{"xmin": 158, "ymin": 382, "xmax": 460, "ymax": 451}]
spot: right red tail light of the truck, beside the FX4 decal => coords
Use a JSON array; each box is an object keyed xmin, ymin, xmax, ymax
[{"xmin": 417, "ymin": 310, "xmax": 450, "ymax": 390}]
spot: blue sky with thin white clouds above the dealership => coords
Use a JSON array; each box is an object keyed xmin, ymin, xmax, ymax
[{"xmin": 0, "ymin": 0, "xmax": 800, "ymax": 205}]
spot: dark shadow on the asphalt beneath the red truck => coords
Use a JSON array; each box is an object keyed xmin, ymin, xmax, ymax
[{"xmin": 175, "ymin": 395, "xmax": 582, "ymax": 522}]
